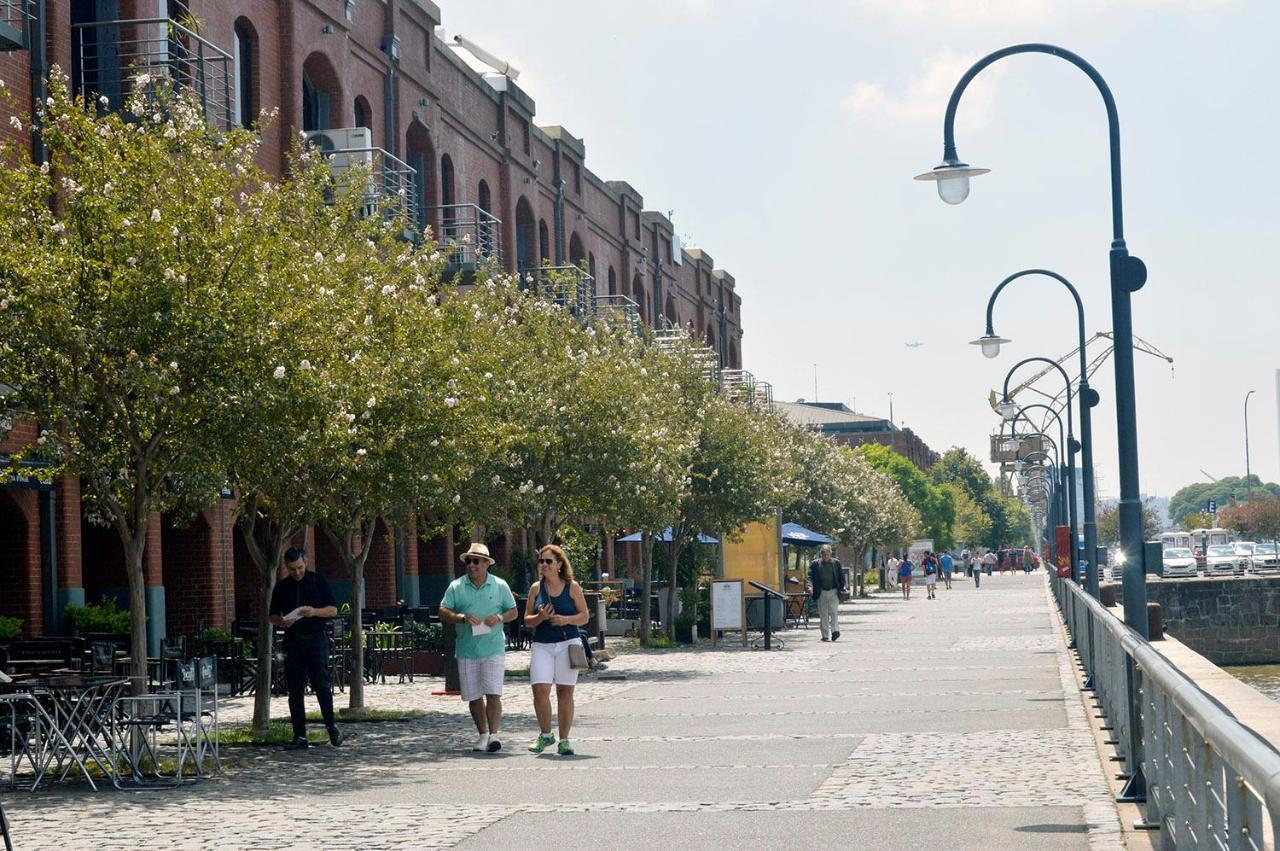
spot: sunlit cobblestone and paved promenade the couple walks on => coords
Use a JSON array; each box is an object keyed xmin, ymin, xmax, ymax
[{"xmin": 5, "ymin": 575, "xmax": 1123, "ymax": 850}]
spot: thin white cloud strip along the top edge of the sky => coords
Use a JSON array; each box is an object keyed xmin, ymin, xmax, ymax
[{"xmin": 850, "ymin": 0, "xmax": 1236, "ymax": 27}]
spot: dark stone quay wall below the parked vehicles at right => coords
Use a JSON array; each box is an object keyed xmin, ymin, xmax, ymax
[{"xmin": 1147, "ymin": 577, "xmax": 1280, "ymax": 665}]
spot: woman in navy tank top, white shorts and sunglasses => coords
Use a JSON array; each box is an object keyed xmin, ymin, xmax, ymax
[{"xmin": 525, "ymin": 544, "xmax": 588, "ymax": 756}]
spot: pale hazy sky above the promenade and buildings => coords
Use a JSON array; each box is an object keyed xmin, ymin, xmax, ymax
[{"xmin": 440, "ymin": 0, "xmax": 1280, "ymax": 498}]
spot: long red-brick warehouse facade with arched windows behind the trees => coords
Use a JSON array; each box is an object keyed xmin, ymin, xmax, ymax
[{"xmin": 0, "ymin": 0, "xmax": 742, "ymax": 637}]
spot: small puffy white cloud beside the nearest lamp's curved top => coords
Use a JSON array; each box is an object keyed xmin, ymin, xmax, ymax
[{"xmin": 844, "ymin": 50, "xmax": 1001, "ymax": 127}]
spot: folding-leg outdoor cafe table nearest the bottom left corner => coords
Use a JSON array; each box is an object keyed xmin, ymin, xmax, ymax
[{"xmin": 0, "ymin": 674, "xmax": 129, "ymax": 791}]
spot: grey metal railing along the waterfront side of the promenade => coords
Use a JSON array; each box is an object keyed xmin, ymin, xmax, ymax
[{"xmin": 1051, "ymin": 573, "xmax": 1280, "ymax": 851}]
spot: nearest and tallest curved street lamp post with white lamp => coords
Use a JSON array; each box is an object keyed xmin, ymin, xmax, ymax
[{"xmin": 916, "ymin": 44, "xmax": 1148, "ymax": 637}]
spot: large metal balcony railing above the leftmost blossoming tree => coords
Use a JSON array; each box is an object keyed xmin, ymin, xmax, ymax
[{"xmin": 72, "ymin": 18, "xmax": 236, "ymax": 129}]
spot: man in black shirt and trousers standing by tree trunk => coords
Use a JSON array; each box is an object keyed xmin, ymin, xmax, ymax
[{"xmin": 271, "ymin": 546, "xmax": 342, "ymax": 750}]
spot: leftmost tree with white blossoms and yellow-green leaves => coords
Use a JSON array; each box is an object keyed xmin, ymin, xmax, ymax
[{"xmin": 0, "ymin": 69, "xmax": 260, "ymax": 691}]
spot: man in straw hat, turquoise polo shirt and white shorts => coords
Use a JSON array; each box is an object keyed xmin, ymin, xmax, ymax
[{"xmin": 440, "ymin": 544, "xmax": 516, "ymax": 754}]
